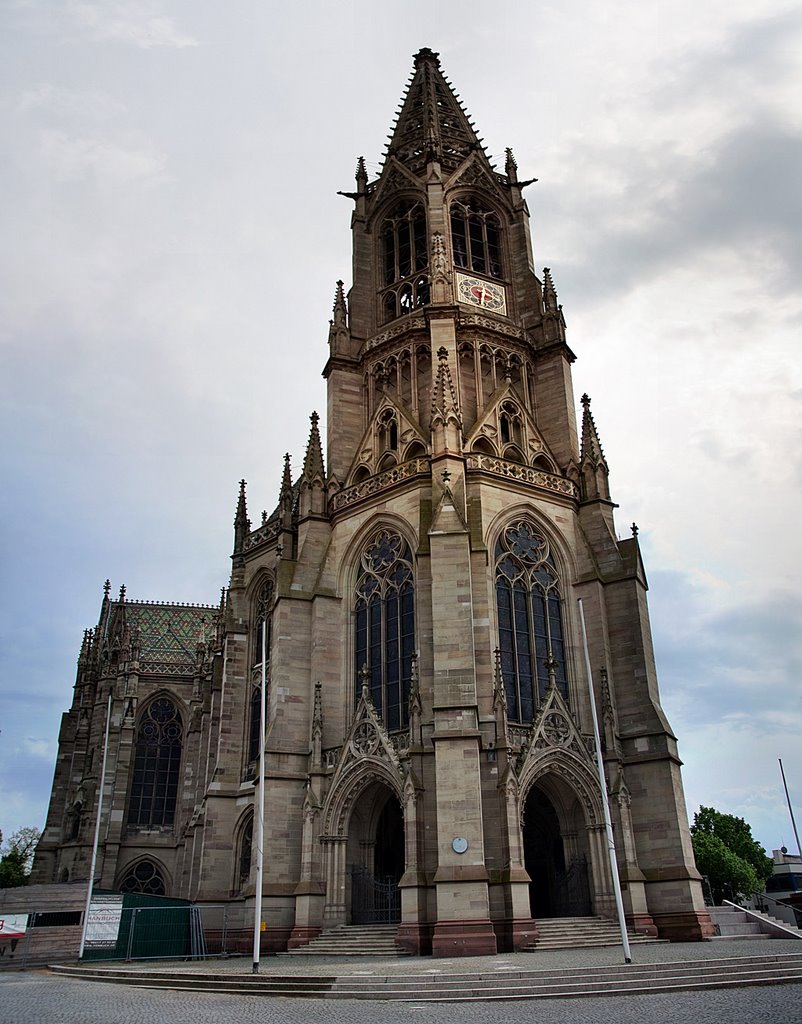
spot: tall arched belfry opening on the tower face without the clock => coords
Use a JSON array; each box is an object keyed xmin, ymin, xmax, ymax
[{"xmin": 381, "ymin": 200, "xmax": 429, "ymax": 321}]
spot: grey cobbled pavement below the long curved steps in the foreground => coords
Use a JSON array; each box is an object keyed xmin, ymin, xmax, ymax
[{"xmin": 0, "ymin": 971, "xmax": 802, "ymax": 1024}]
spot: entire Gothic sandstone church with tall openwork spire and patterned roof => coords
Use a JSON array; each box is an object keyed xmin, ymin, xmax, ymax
[{"xmin": 32, "ymin": 49, "xmax": 713, "ymax": 955}]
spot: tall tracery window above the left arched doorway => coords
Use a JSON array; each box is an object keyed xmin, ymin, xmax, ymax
[{"xmin": 354, "ymin": 529, "xmax": 415, "ymax": 730}]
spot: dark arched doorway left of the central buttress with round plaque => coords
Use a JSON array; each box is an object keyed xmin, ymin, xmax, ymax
[{"xmin": 348, "ymin": 782, "xmax": 405, "ymax": 925}]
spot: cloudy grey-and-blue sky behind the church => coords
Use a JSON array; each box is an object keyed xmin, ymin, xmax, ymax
[{"xmin": 0, "ymin": 0, "xmax": 802, "ymax": 850}]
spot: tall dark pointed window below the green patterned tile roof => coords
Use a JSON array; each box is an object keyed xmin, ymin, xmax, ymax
[{"xmin": 128, "ymin": 697, "xmax": 183, "ymax": 828}]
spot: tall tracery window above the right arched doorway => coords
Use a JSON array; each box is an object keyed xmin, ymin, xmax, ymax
[{"xmin": 495, "ymin": 519, "xmax": 567, "ymax": 722}]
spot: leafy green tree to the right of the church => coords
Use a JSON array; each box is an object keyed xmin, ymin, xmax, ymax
[{"xmin": 690, "ymin": 807, "xmax": 773, "ymax": 903}]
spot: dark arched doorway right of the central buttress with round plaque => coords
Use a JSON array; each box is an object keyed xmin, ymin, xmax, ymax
[{"xmin": 523, "ymin": 785, "xmax": 593, "ymax": 918}]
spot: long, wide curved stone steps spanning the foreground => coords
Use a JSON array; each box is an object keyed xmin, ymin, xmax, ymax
[{"xmin": 49, "ymin": 953, "xmax": 802, "ymax": 1004}]
